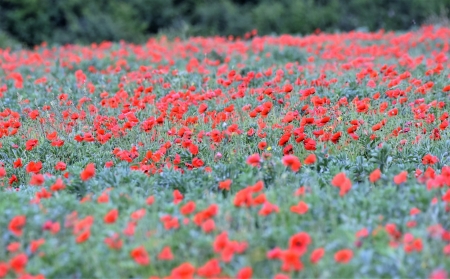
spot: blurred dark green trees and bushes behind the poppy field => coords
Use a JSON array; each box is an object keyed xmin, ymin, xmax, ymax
[{"xmin": 0, "ymin": 0, "xmax": 450, "ymax": 47}]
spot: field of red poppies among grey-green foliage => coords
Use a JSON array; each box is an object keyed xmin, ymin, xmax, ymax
[{"xmin": 0, "ymin": 26, "xmax": 450, "ymax": 279}]
